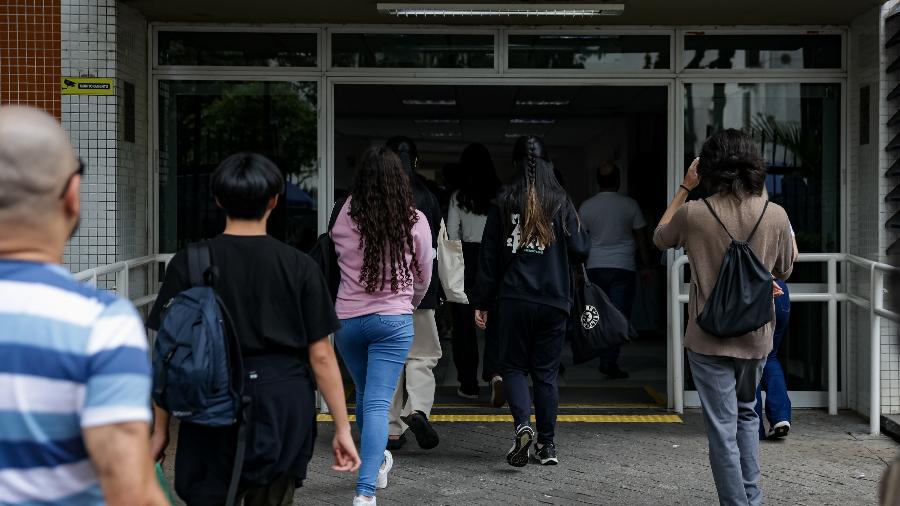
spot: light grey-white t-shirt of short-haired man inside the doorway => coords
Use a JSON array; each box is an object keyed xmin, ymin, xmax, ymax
[{"xmin": 579, "ymin": 192, "xmax": 647, "ymax": 271}]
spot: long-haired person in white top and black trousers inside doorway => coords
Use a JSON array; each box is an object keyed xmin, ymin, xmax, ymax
[{"xmin": 447, "ymin": 144, "xmax": 506, "ymax": 407}]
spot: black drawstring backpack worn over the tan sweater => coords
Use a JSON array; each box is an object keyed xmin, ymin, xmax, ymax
[{"xmin": 697, "ymin": 199, "xmax": 774, "ymax": 337}]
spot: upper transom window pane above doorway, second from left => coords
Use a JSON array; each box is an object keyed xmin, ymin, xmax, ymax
[{"xmin": 331, "ymin": 33, "xmax": 494, "ymax": 69}]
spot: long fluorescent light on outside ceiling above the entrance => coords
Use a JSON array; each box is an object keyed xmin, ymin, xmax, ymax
[{"xmin": 378, "ymin": 3, "xmax": 625, "ymax": 17}]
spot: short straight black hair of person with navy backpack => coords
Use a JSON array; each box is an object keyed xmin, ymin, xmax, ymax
[{"xmin": 209, "ymin": 153, "xmax": 284, "ymax": 220}]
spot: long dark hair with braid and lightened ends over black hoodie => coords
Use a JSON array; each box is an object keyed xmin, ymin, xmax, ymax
[{"xmin": 499, "ymin": 135, "xmax": 569, "ymax": 247}]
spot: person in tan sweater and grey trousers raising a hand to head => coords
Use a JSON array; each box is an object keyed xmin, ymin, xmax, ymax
[{"xmin": 653, "ymin": 129, "xmax": 796, "ymax": 505}]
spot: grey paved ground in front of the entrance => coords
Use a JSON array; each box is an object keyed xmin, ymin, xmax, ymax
[{"xmin": 158, "ymin": 411, "xmax": 900, "ymax": 506}]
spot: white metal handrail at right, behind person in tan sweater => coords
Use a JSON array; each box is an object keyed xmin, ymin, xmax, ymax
[{"xmin": 669, "ymin": 253, "xmax": 900, "ymax": 435}]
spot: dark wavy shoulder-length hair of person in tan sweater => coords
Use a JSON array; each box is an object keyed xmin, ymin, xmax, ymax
[{"xmin": 697, "ymin": 128, "xmax": 766, "ymax": 197}]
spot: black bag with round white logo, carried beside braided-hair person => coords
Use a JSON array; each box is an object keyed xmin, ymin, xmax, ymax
[{"xmin": 568, "ymin": 264, "xmax": 629, "ymax": 364}]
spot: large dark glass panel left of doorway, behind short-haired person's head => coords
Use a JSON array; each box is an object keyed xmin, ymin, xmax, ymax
[{"xmin": 159, "ymin": 81, "xmax": 319, "ymax": 252}]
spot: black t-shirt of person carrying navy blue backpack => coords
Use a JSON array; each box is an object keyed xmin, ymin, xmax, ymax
[{"xmin": 147, "ymin": 235, "xmax": 340, "ymax": 359}]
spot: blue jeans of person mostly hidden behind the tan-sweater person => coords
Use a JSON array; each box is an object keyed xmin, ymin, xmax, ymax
[{"xmin": 756, "ymin": 280, "xmax": 791, "ymax": 439}]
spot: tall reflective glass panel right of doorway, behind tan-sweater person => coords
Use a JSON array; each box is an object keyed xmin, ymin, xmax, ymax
[{"xmin": 684, "ymin": 83, "xmax": 841, "ymax": 390}]
